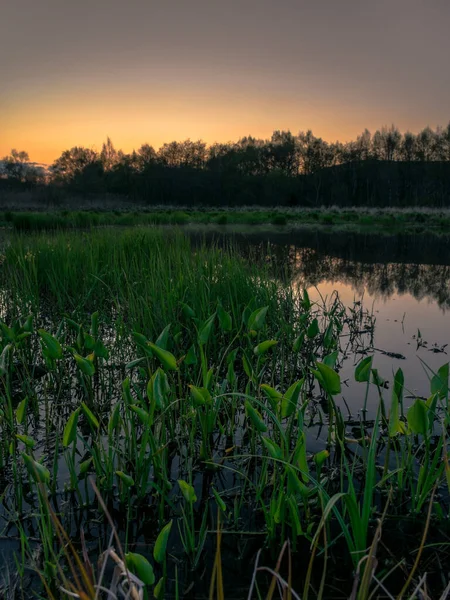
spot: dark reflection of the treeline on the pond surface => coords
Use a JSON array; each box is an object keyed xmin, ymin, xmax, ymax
[{"xmin": 194, "ymin": 229, "xmax": 450, "ymax": 311}]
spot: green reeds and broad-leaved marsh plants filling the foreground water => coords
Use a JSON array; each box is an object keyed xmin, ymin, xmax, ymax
[{"xmin": 0, "ymin": 229, "xmax": 450, "ymax": 600}]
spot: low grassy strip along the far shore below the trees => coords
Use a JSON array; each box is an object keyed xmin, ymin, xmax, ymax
[{"xmin": 0, "ymin": 208, "xmax": 450, "ymax": 231}]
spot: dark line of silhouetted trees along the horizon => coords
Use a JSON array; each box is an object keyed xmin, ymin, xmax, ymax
[{"xmin": 0, "ymin": 123, "xmax": 450, "ymax": 207}]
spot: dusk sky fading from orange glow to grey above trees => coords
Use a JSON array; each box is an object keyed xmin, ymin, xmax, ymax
[{"xmin": 0, "ymin": 0, "xmax": 450, "ymax": 163}]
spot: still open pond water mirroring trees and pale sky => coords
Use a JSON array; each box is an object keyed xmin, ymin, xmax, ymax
[{"xmin": 192, "ymin": 229, "xmax": 450, "ymax": 417}]
